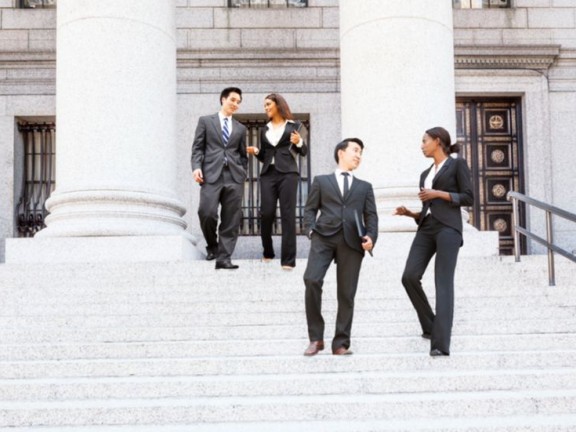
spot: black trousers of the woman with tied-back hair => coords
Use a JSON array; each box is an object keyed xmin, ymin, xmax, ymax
[{"xmin": 402, "ymin": 215, "xmax": 462, "ymax": 354}]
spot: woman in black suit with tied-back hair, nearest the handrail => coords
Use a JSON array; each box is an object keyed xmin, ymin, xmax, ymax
[{"xmin": 395, "ymin": 127, "xmax": 474, "ymax": 356}]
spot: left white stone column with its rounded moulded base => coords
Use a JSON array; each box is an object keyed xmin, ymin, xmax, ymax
[{"xmin": 5, "ymin": 0, "xmax": 196, "ymax": 261}]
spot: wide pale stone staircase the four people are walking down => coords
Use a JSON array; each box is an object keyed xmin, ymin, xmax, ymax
[{"xmin": 0, "ymin": 254, "xmax": 576, "ymax": 432}]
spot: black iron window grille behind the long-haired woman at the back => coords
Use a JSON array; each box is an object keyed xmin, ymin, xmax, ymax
[{"xmin": 235, "ymin": 116, "xmax": 311, "ymax": 235}]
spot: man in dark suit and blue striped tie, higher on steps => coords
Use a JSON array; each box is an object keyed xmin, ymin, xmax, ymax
[{"xmin": 192, "ymin": 87, "xmax": 248, "ymax": 269}]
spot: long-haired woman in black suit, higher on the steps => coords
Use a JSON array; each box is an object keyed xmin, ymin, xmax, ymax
[{"xmin": 247, "ymin": 93, "xmax": 308, "ymax": 270}]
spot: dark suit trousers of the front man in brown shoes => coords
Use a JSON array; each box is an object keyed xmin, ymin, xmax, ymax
[{"xmin": 304, "ymin": 231, "xmax": 364, "ymax": 352}]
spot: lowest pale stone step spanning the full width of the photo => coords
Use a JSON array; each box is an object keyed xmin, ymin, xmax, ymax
[{"xmin": 0, "ymin": 390, "xmax": 576, "ymax": 427}]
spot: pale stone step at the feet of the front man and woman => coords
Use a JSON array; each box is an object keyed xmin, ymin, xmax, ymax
[{"xmin": 0, "ymin": 333, "xmax": 576, "ymax": 362}]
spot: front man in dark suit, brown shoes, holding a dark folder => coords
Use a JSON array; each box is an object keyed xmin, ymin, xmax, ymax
[{"xmin": 304, "ymin": 138, "xmax": 378, "ymax": 356}]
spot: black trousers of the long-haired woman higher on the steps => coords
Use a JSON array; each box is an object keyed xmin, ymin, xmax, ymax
[{"xmin": 260, "ymin": 165, "xmax": 298, "ymax": 267}]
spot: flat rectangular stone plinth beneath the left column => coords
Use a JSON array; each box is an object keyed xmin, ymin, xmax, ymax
[{"xmin": 6, "ymin": 235, "xmax": 202, "ymax": 264}]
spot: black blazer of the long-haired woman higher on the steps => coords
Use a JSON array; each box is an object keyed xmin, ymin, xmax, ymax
[{"xmin": 256, "ymin": 120, "xmax": 308, "ymax": 175}]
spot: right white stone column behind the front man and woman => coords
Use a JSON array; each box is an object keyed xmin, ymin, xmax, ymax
[{"xmin": 340, "ymin": 0, "xmax": 456, "ymax": 231}]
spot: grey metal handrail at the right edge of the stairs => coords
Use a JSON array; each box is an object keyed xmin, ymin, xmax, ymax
[{"xmin": 507, "ymin": 191, "xmax": 576, "ymax": 286}]
